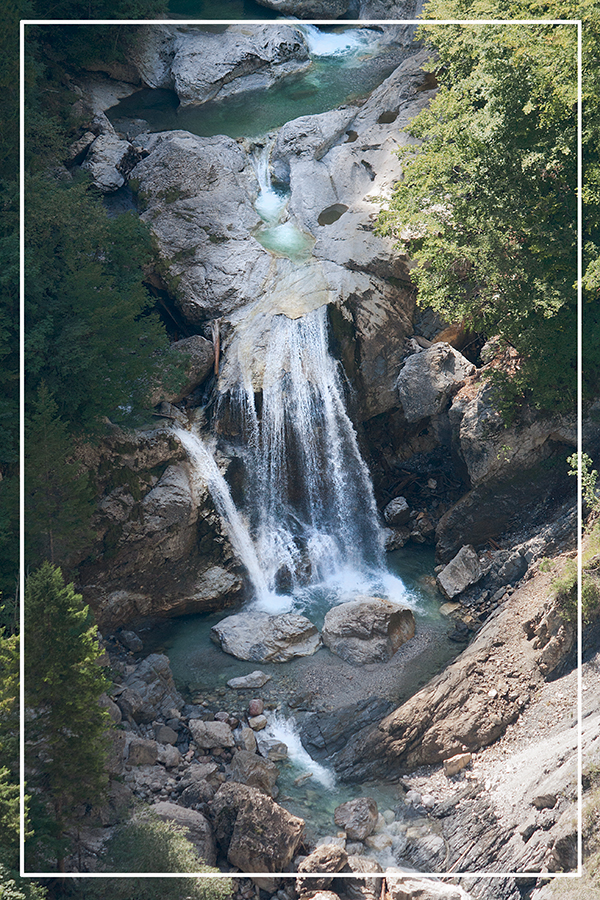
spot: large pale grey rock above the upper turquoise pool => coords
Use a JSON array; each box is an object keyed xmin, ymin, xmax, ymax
[{"xmin": 134, "ymin": 24, "xmax": 310, "ymax": 107}]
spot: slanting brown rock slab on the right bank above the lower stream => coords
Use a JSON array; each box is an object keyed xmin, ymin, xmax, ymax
[{"xmin": 336, "ymin": 574, "xmax": 574, "ymax": 779}]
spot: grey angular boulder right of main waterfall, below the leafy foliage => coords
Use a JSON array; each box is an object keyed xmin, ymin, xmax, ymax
[{"xmin": 396, "ymin": 342, "xmax": 475, "ymax": 422}]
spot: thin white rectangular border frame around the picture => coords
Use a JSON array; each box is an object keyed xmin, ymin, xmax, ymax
[{"xmin": 19, "ymin": 18, "xmax": 583, "ymax": 881}]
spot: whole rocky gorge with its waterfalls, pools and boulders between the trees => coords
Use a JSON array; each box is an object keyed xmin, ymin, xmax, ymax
[{"xmin": 23, "ymin": 14, "xmax": 599, "ymax": 900}]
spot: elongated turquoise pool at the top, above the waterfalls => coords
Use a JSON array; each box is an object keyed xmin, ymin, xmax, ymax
[{"xmin": 107, "ymin": 33, "xmax": 406, "ymax": 138}]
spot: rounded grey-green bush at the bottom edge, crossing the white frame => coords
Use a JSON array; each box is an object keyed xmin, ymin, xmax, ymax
[{"xmin": 86, "ymin": 813, "xmax": 232, "ymax": 900}]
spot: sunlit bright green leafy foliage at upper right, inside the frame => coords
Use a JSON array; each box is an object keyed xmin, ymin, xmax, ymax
[{"xmin": 380, "ymin": 0, "xmax": 577, "ymax": 409}]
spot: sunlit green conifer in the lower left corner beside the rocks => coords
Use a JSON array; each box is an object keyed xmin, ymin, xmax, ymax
[{"xmin": 24, "ymin": 562, "xmax": 110, "ymax": 872}]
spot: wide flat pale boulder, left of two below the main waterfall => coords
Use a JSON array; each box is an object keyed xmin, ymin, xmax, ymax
[{"xmin": 210, "ymin": 612, "xmax": 321, "ymax": 662}]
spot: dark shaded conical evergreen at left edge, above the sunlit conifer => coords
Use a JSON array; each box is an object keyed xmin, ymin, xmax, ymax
[{"xmin": 25, "ymin": 382, "xmax": 94, "ymax": 566}]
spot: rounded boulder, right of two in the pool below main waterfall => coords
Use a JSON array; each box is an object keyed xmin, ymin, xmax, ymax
[{"xmin": 321, "ymin": 597, "xmax": 415, "ymax": 665}]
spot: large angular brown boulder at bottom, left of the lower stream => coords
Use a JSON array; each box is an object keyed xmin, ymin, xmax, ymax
[{"xmin": 210, "ymin": 783, "xmax": 304, "ymax": 872}]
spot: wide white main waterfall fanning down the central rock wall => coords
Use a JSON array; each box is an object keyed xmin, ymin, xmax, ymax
[{"xmin": 216, "ymin": 306, "xmax": 384, "ymax": 593}]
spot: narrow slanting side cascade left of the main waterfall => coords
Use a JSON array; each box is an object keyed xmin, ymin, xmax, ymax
[{"xmin": 175, "ymin": 428, "xmax": 269, "ymax": 598}]
